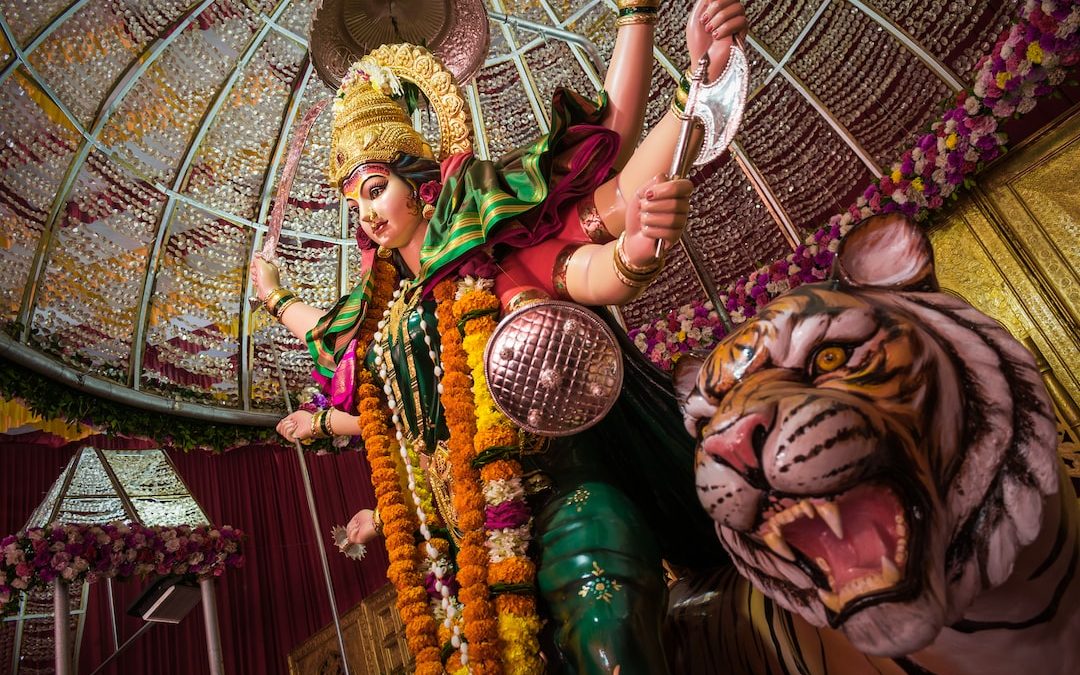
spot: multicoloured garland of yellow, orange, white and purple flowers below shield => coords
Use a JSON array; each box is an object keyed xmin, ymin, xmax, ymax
[{"xmin": 453, "ymin": 285, "xmax": 543, "ymax": 675}]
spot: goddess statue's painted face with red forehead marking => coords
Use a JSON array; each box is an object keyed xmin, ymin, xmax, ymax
[{"xmin": 341, "ymin": 162, "xmax": 424, "ymax": 248}]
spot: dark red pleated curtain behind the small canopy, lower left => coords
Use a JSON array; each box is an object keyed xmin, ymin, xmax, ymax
[{"xmin": 0, "ymin": 435, "xmax": 387, "ymax": 675}]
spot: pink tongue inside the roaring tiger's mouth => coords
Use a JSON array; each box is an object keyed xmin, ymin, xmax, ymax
[{"xmin": 781, "ymin": 487, "xmax": 903, "ymax": 591}]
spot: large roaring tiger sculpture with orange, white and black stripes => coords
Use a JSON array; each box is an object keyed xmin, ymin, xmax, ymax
[{"xmin": 669, "ymin": 215, "xmax": 1080, "ymax": 675}]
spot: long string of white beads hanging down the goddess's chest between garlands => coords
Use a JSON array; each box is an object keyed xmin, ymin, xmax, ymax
[{"xmin": 373, "ymin": 279, "xmax": 469, "ymax": 663}]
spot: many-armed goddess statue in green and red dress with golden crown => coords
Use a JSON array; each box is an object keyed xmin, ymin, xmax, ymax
[{"xmin": 251, "ymin": 0, "xmax": 746, "ymax": 675}]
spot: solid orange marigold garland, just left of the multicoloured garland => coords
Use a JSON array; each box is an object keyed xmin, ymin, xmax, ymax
[{"xmin": 434, "ymin": 281, "xmax": 502, "ymax": 675}]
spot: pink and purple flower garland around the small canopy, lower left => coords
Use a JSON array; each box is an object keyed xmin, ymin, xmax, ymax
[{"xmin": 0, "ymin": 523, "xmax": 244, "ymax": 617}]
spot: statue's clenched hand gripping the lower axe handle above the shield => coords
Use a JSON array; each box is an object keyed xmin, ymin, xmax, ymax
[{"xmin": 623, "ymin": 176, "xmax": 693, "ymax": 262}]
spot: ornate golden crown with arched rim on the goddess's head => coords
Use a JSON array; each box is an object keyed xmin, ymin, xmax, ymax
[{"xmin": 329, "ymin": 44, "xmax": 472, "ymax": 186}]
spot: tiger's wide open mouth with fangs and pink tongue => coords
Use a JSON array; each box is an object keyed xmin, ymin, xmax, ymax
[{"xmin": 756, "ymin": 485, "xmax": 909, "ymax": 625}]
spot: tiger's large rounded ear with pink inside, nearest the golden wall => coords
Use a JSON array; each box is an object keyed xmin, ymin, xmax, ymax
[{"xmin": 832, "ymin": 213, "xmax": 939, "ymax": 292}]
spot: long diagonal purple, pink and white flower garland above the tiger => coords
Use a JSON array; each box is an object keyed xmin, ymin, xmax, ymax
[{"xmin": 630, "ymin": 0, "xmax": 1080, "ymax": 369}]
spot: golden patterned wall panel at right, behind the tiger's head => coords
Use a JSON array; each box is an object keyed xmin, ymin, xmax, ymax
[{"xmin": 930, "ymin": 107, "xmax": 1080, "ymax": 436}]
